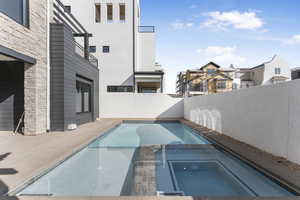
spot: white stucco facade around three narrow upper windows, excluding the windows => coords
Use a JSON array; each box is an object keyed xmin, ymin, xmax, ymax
[{"xmin": 62, "ymin": 0, "xmax": 139, "ymax": 93}]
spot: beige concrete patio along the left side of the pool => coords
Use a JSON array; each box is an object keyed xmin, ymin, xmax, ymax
[{"xmin": 0, "ymin": 119, "xmax": 121, "ymax": 195}]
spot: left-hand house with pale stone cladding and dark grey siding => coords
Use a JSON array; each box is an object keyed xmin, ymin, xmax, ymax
[{"xmin": 0, "ymin": 0, "xmax": 99, "ymax": 135}]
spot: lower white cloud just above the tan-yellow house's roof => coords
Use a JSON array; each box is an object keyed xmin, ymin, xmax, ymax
[{"xmin": 197, "ymin": 46, "xmax": 246, "ymax": 67}]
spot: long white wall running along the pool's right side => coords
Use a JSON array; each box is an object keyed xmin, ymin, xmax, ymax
[{"xmin": 184, "ymin": 80, "xmax": 300, "ymax": 164}]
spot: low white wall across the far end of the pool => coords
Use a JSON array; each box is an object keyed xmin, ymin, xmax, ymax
[{"xmin": 100, "ymin": 93, "xmax": 184, "ymax": 119}]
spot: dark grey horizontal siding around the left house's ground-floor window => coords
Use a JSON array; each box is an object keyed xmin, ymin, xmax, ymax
[{"xmin": 50, "ymin": 24, "xmax": 99, "ymax": 130}]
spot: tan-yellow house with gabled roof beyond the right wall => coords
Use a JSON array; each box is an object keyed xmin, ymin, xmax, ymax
[{"xmin": 177, "ymin": 62, "xmax": 235, "ymax": 96}]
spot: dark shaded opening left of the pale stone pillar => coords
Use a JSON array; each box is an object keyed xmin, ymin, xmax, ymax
[{"xmin": 0, "ymin": 62, "xmax": 24, "ymax": 131}]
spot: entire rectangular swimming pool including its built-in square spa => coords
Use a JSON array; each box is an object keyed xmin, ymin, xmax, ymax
[{"xmin": 18, "ymin": 122, "xmax": 293, "ymax": 196}]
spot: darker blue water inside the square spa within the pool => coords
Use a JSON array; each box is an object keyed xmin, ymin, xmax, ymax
[{"xmin": 170, "ymin": 161, "xmax": 255, "ymax": 196}]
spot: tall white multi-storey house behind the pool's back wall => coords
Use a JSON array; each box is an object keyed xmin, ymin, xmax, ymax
[{"xmin": 59, "ymin": 0, "xmax": 165, "ymax": 93}]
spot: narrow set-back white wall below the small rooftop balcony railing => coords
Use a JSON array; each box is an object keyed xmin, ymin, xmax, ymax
[{"xmin": 137, "ymin": 33, "xmax": 156, "ymax": 71}]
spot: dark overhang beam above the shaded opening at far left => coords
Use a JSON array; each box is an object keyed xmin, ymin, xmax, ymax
[{"xmin": 0, "ymin": 45, "xmax": 36, "ymax": 65}]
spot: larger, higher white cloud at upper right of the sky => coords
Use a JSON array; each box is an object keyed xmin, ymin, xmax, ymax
[{"xmin": 202, "ymin": 11, "xmax": 265, "ymax": 30}]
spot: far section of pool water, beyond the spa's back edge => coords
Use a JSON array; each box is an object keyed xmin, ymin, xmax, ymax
[{"xmin": 92, "ymin": 122, "xmax": 209, "ymax": 147}]
